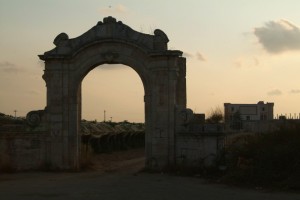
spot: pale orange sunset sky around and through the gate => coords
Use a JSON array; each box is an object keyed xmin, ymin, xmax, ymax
[{"xmin": 0, "ymin": 0, "xmax": 300, "ymax": 122}]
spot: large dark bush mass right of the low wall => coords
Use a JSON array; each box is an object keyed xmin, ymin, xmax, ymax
[{"xmin": 222, "ymin": 123, "xmax": 300, "ymax": 190}]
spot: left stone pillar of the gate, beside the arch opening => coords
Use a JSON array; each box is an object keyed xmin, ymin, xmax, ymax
[{"xmin": 43, "ymin": 61, "xmax": 81, "ymax": 169}]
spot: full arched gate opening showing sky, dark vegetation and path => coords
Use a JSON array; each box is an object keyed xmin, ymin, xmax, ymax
[{"xmin": 79, "ymin": 64, "xmax": 145, "ymax": 170}]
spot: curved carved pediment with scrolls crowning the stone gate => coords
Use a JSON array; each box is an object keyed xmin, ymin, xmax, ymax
[{"xmin": 39, "ymin": 16, "xmax": 173, "ymax": 60}]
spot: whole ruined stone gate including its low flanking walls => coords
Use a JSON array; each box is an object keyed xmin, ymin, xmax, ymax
[{"xmin": 0, "ymin": 17, "xmax": 223, "ymax": 171}]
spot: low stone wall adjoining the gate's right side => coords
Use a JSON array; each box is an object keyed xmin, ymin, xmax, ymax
[{"xmin": 176, "ymin": 133, "xmax": 225, "ymax": 167}]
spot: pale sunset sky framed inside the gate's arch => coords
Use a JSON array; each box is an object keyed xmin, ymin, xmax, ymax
[{"xmin": 81, "ymin": 64, "xmax": 145, "ymax": 123}]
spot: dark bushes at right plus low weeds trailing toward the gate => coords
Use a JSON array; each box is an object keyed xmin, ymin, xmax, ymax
[{"xmin": 161, "ymin": 122, "xmax": 300, "ymax": 190}]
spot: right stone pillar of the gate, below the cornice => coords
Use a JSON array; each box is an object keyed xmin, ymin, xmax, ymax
[{"xmin": 148, "ymin": 62, "xmax": 177, "ymax": 169}]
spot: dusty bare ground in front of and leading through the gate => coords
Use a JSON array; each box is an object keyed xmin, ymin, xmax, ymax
[{"xmin": 0, "ymin": 150, "xmax": 300, "ymax": 200}]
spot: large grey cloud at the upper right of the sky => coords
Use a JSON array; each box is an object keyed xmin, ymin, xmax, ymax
[{"xmin": 254, "ymin": 20, "xmax": 300, "ymax": 54}]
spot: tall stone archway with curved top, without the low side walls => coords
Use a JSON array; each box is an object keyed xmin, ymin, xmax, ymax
[{"xmin": 39, "ymin": 17, "xmax": 187, "ymax": 169}]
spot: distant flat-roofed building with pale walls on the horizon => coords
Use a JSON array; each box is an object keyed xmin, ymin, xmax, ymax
[{"xmin": 224, "ymin": 101, "xmax": 274, "ymax": 124}]
